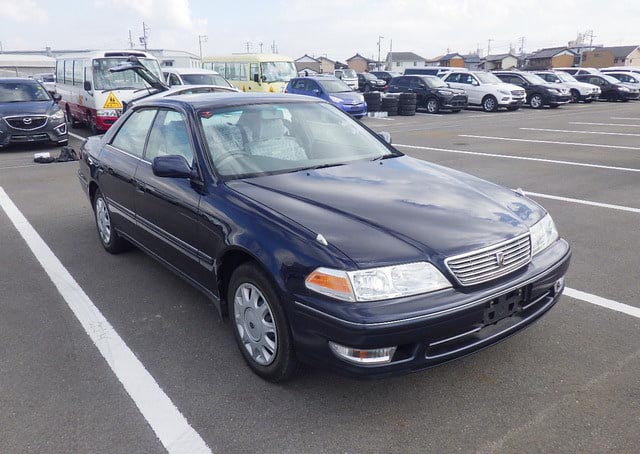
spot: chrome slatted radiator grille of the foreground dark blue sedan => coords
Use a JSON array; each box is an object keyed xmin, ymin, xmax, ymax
[{"xmin": 445, "ymin": 233, "xmax": 531, "ymax": 285}]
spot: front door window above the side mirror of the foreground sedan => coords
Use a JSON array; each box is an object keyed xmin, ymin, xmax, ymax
[{"xmin": 144, "ymin": 110, "xmax": 193, "ymax": 165}]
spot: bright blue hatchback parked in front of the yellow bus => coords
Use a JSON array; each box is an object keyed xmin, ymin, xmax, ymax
[{"xmin": 285, "ymin": 76, "xmax": 367, "ymax": 118}]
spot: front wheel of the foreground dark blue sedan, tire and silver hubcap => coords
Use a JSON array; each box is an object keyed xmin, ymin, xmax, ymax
[{"xmin": 227, "ymin": 262, "xmax": 296, "ymax": 383}]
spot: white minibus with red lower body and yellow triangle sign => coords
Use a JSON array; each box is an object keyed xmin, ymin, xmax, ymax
[{"xmin": 56, "ymin": 50, "xmax": 162, "ymax": 134}]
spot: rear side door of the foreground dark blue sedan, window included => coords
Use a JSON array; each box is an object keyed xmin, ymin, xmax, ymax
[{"xmin": 98, "ymin": 109, "xmax": 156, "ymax": 237}]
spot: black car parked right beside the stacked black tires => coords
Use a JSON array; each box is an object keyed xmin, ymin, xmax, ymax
[{"xmin": 386, "ymin": 76, "xmax": 468, "ymax": 114}]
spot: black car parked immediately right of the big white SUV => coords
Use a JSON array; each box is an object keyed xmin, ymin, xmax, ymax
[{"xmin": 493, "ymin": 71, "xmax": 571, "ymax": 109}]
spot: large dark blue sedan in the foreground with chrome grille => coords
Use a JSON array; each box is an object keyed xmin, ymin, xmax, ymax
[{"xmin": 79, "ymin": 94, "xmax": 571, "ymax": 381}]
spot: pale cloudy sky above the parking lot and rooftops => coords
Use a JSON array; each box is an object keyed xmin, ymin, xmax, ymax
[{"xmin": 0, "ymin": 0, "xmax": 640, "ymax": 61}]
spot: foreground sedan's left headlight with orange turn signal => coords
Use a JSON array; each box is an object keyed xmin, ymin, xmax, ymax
[{"xmin": 305, "ymin": 262, "xmax": 451, "ymax": 302}]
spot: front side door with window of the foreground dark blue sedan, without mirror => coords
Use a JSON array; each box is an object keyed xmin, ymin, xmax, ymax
[{"xmin": 135, "ymin": 109, "xmax": 204, "ymax": 281}]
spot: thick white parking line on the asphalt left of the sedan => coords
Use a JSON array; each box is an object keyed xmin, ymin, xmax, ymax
[{"xmin": 0, "ymin": 187, "xmax": 211, "ymax": 454}]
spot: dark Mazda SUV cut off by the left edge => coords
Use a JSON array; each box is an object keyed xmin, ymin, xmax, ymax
[{"xmin": 0, "ymin": 78, "xmax": 69, "ymax": 147}]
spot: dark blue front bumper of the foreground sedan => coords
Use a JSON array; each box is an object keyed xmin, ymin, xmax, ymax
[{"xmin": 291, "ymin": 240, "xmax": 571, "ymax": 377}]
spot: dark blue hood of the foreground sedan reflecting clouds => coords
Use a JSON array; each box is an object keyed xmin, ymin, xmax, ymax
[{"xmin": 227, "ymin": 156, "xmax": 544, "ymax": 268}]
